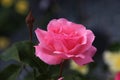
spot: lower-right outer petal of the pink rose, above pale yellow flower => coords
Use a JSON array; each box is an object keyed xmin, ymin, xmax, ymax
[{"xmin": 72, "ymin": 46, "xmax": 96, "ymax": 65}]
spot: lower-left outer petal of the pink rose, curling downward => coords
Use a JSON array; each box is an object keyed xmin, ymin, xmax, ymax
[{"xmin": 35, "ymin": 46, "xmax": 63, "ymax": 65}]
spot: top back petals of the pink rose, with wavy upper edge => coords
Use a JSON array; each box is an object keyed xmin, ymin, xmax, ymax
[{"xmin": 47, "ymin": 18, "xmax": 86, "ymax": 34}]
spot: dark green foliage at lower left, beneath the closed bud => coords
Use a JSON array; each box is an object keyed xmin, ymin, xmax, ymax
[{"xmin": 0, "ymin": 41, "xmax": 58, "ymax": 80}]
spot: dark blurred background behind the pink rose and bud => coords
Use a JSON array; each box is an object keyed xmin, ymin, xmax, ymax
[{"xmin": 0, "ymin": 0, "xmax": 120, "ymax": 80}]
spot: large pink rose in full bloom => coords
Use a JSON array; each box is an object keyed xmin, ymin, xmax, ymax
[{"xmin": 35, "ymin": 18, "xmax": 96, "ymax": 65}]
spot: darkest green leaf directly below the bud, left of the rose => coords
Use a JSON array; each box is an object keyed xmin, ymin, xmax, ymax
[{"xmin": 15, "ymin": 41, "xmax": 34, "ymax": 63}]
